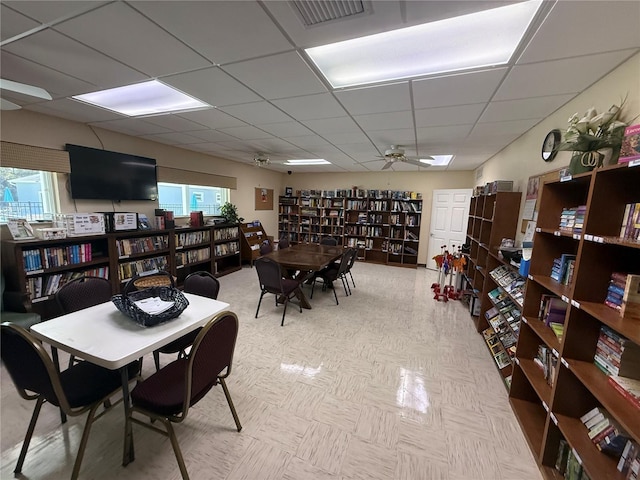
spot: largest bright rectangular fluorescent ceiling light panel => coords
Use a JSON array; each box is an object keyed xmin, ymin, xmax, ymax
[{"xmin": 305, "ymin": 0, "xmax": 542, "ymax": 88}]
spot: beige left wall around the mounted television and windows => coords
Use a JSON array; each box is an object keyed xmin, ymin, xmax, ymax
[{"xmin": 0, "ymin": 110, "xmax": 284, "ymax": 235}]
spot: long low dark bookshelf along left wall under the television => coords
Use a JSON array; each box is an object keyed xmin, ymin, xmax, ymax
[{"xmin": 2, "ymin": 225, "xmax": 241, "ymax": 319}]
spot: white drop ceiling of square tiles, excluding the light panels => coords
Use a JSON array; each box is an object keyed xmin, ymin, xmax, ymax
[{"xmin": 0, "ymin": 0, "xmax": 640, "ymax": 172}]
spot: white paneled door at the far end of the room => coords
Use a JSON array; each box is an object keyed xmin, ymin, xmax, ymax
[{"xmin": 427, "ymin": 188, "xmax": 473, "ymax": 270}]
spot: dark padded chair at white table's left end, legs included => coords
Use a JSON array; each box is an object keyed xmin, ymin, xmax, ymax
[{"xmin": 0, "ymin": 323, "xmax": 140, "ymax": 480}]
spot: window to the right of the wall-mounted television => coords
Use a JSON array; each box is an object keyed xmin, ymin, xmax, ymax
[{"xmin": 158, "ymin": 182, "xmax": 229, "ymax": 216}]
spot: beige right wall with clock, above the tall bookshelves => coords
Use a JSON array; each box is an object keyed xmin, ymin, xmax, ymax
[{"xmin": 474, "ymin": 54, "xmax": 640, "ymax": 242}]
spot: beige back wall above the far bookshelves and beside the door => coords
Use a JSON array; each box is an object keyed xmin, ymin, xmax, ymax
[{"xmin": 285, "ymin": 171, "xmax": 474, "ymax": 265}]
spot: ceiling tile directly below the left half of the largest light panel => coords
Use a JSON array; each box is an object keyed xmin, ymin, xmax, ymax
[{"xmin": 335, "ymin": 82, "xmax": 411, "ymax": 115}]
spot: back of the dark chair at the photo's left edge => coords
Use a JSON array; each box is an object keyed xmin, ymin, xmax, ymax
[{"xmin": 0, "ymin": 323, "xmax": 63, "ymax": 409}]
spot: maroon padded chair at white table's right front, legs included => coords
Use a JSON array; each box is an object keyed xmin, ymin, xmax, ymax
[{"xmin": 125, "ymin": 311, "xmax": 242, "ymax": 480}]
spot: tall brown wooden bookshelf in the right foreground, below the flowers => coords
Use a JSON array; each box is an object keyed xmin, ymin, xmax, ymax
[{"xmin": 509, "ymin": 165, "xmax": 640, "ymax": 479}]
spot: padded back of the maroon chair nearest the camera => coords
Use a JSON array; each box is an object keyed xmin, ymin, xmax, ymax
[{"xmin": 184, "ymin": 311, "xmax": 238, "ymax": 408}]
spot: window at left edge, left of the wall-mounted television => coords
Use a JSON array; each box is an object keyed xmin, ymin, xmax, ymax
[{"xmin": 0, "ymin": 167, "xmax": 59, "ymax": 222}]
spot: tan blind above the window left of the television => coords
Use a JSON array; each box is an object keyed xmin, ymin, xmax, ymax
[{"xmin": 0, "ymin": 141, "xmax": 71, "ymax": 173}]
